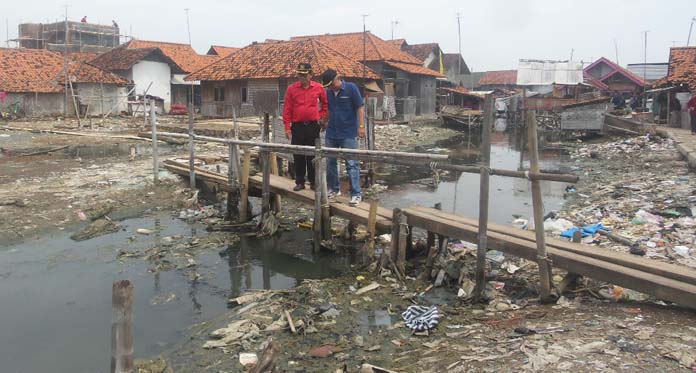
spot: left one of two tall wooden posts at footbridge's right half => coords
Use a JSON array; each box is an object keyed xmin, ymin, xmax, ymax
[{"xmin": 474, "ymin": 94, "xmax": 493, "ymax": 300}]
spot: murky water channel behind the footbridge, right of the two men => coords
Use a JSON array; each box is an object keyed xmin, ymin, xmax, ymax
[{"xmin": 377, "ymin": 119, "xmax": 569, "ymax": 224}]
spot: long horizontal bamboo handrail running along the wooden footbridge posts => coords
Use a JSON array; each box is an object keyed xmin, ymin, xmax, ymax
[{"xmin": 160, "ymin": 132, "xmax": 579, "ymax": 183}]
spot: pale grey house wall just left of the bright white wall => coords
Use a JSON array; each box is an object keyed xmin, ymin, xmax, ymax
[{"xmin": 73, "ymin": 83, "xmax": 128, "ymax": 116}]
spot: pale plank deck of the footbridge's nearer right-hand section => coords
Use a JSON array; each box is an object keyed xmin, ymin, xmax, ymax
[{"xmin": 402, "ymin": 207, "xmax": 696, "ymax": 308}]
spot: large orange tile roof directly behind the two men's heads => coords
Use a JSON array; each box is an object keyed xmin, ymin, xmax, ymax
[{"xmin": 186, "ymin": 39, "xmax": 381, "ymax": 81}]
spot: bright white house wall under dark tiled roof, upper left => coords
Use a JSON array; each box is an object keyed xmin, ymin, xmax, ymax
[{"xmin": 131, "ymin": 61, "xmax": 172, "ymax": 112}]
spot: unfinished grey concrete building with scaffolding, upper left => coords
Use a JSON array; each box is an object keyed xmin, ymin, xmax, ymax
[{"xmin": 14, "ymin": 21, "xmax": 120, "ymax": 53}]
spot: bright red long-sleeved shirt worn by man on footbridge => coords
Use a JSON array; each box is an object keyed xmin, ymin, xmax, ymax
[{"xmin": 283, "ymin": 81, "xmax": 328, "ymax": 131}]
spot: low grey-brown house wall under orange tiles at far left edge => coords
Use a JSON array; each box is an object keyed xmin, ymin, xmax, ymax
[{"xmin": 0, "ymin": 92, "xmax": 69, "ymax": 118}]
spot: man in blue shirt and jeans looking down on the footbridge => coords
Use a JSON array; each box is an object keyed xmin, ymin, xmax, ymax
[{"xmin": 321, "ymin": 69, "xmax": 365, "ymax": 206}]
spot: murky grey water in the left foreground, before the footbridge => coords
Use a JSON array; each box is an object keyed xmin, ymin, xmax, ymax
[{"xmin": 0, "ymin": 213, "xmax": 350, "ymax": 372}]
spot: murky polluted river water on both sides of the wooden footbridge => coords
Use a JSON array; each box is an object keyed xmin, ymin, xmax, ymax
[{"xmin": 0, "ymin": 121, "xmax": 569, "ymax": 372}]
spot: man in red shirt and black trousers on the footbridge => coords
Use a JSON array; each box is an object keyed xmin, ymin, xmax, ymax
[{"xmin": 283, "ymin": 63, "xmax": 328, "ymax": 191}]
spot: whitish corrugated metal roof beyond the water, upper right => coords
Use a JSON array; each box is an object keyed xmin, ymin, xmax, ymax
[{"xmin": 517, "ymin": 60, "xmax": 583, "ymax": 85}]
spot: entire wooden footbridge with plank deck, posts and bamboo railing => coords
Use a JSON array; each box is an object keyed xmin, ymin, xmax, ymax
[{"xmin": 153, "ymin": 97, "xmax": 696, "ymax": 309}]
